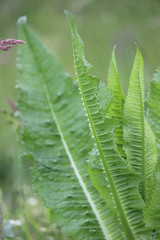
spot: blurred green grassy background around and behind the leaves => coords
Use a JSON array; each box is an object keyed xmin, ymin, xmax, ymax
[{"xmin": 0, "ymin": 0, "xmax": 160, "ymax": 239}]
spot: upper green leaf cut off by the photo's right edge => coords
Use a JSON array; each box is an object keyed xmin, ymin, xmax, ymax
[{"xmin": 146, "ymin": 67, "xmax": 160, "ymax": 160}]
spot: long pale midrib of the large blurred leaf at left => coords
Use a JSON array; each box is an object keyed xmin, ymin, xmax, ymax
[{"xmin": 23, "ymin": 27, "xmax": 111, "ymax": 240}]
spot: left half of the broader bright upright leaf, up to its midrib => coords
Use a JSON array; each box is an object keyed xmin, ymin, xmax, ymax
[{"xmin": 123, "ymin": 48, "xmax": 145, "ymax": 176}]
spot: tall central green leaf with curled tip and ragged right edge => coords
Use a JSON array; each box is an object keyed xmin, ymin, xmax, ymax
[{"xmin": 66, "ymin": 11, "xmax": 149, "ymax": 239}]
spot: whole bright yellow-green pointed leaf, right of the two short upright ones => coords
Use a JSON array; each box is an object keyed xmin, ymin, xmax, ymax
[{"xmin": 123, "ymin": 48, "xmax": 157, "ymax": 203}]
